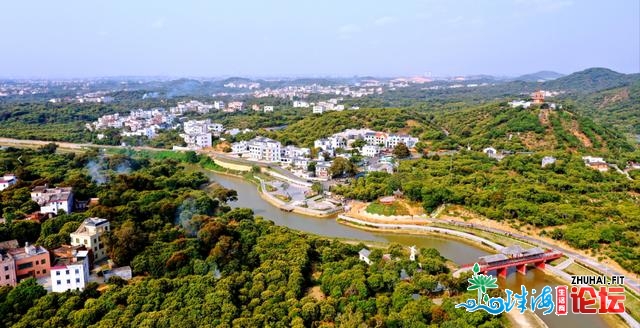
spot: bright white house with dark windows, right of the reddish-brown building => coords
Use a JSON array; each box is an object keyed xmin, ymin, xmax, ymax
[{"xmin": 50, "ymin": 251, "xmax": 89, "ymax": 293}]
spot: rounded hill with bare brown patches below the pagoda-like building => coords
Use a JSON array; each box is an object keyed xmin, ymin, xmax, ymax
[{"xmin": 436, "ymin": 104, "xmax": 633, "ymax": 152}]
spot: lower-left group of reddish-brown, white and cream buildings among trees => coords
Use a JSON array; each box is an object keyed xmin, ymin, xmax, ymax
[{"xmin": 0, "ymin": 217, "xmax": 131, "ymax": 293}]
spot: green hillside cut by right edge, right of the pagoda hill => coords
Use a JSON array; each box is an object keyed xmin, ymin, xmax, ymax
[{"xmin": 575, "ymin": 81, "xmax": 640, "ymax": 139}]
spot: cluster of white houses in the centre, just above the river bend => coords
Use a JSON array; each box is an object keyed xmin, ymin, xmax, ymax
[{"xmin": 231, "ymin": 129, "xmax": 418, "ymax": 180}]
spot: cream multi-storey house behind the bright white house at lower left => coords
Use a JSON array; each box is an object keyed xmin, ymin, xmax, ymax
[{"xmin": 70, "ymin": 218, "xmax": 110, "ymax": 261}]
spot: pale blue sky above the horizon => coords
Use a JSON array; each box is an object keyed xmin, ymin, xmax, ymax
[{"xmin": 0, "ymin": 0, "xmax": 640, "ymax": 78}]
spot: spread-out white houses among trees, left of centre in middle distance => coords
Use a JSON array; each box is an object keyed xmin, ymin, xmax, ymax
[{"xmin": 86, "ymin": 108, "xmax": 176, "ymax": 139}]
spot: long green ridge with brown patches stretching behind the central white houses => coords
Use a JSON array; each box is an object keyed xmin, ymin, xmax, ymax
[{"xmin": 272, "ymin": 103, "xmax": 632, "ymax": 152}]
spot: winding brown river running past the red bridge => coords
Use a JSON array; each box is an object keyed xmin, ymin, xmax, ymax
[{"xmin": 202, "ymin": 170, "xmax": 611, "ymax": 328}]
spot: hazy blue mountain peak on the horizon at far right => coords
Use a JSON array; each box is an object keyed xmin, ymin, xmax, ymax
[{"xmin": 542, "ymin": 67, "xmax": 640, "ymax": 93}]
